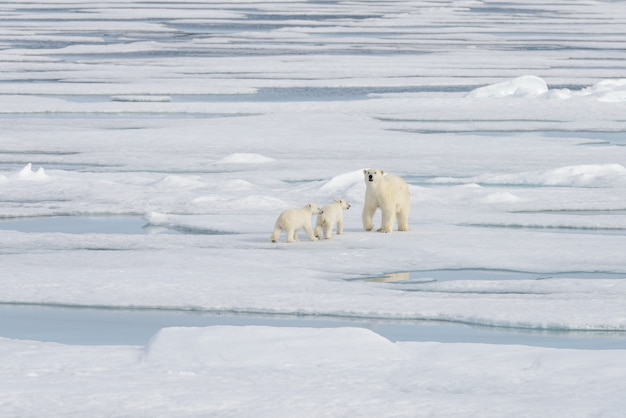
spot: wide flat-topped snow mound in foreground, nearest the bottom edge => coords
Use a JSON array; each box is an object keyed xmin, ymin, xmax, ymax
[{"xmin": 144, "ymin": 326, "xmax": 406, "ymax": 368}]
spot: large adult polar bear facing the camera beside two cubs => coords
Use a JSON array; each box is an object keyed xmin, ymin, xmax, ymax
[{"xmin": 363, "ymin": 169, "xmax": 411, "ymax": 232}]
